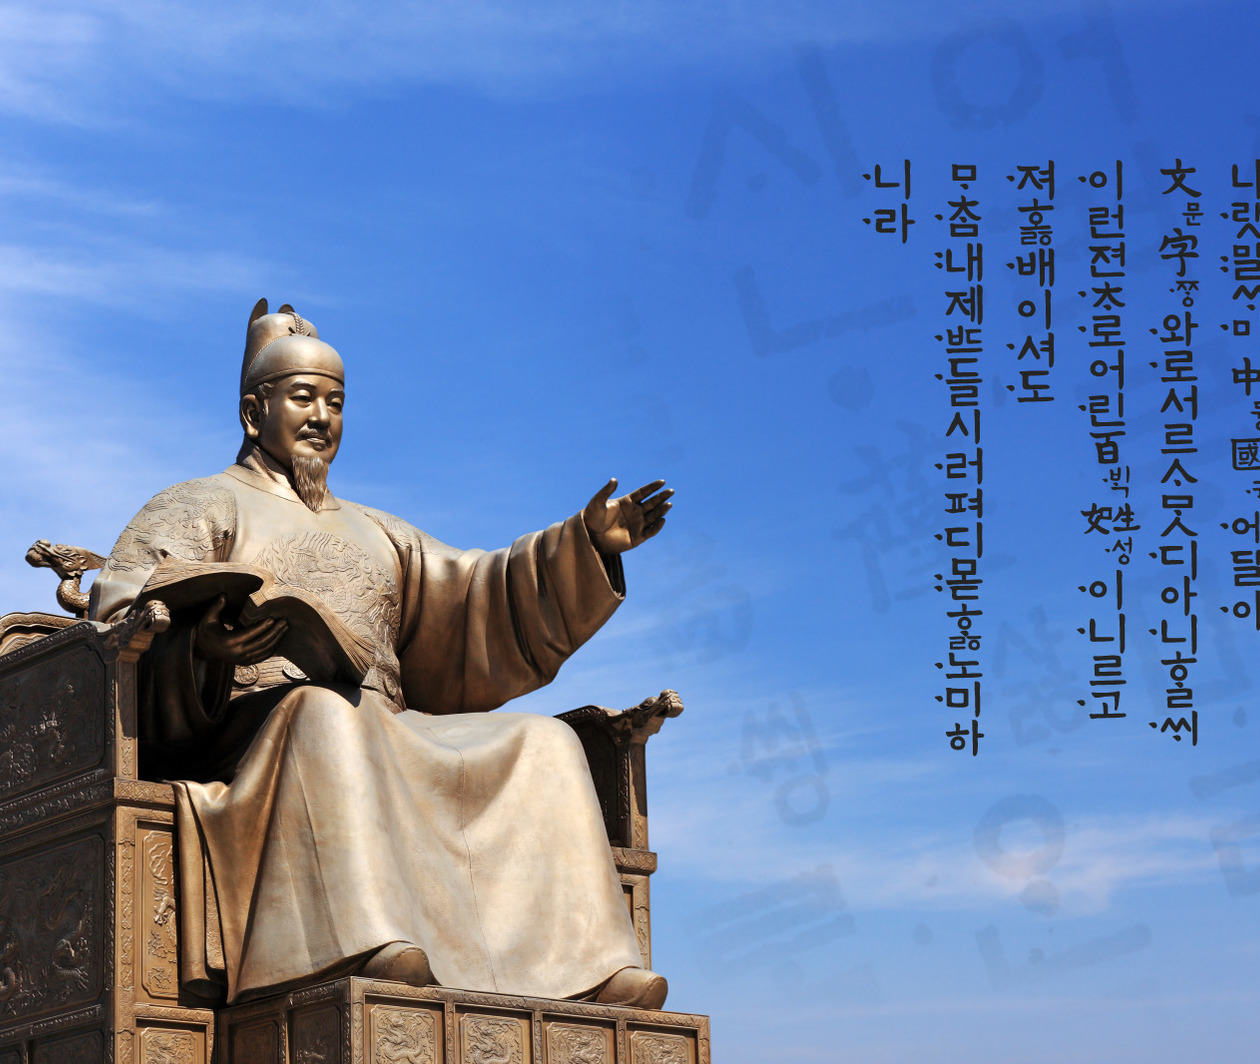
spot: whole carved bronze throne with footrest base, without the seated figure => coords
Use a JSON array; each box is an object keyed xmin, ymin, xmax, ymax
[{"xmin": 0, "ymin": 614, "xmax": 690, "ymax": 1064}]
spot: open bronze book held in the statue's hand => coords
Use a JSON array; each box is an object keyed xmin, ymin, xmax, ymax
[{"xmin": 132, "ymin": 558, "xmax": 374, "ymax": 683}]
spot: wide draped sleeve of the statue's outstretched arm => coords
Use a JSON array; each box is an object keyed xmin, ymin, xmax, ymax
[{"xmin": 369, "ymin": 512, "xmax": 625, "ymax": 714}]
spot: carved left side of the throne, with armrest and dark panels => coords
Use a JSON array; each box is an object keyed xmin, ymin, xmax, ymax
[{"xmin": 0, "ymin": 615, "xmax": 214, "ymax": 1064}]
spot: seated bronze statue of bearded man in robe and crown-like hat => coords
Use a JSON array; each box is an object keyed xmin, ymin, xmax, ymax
[{"xmin": 91, "ymin": 300, "xmax": 672, "ymax": 1009}]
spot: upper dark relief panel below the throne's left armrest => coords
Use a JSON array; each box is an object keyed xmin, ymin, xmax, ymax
[{"xmin": 0, "ymin": 645, "xmax": 105, "ymax": 798}]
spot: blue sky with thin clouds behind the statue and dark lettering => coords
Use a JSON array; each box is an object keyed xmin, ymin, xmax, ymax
[{"xmin": 0, "ymin": 0, "xmax": 1260, "ymax": 1064}]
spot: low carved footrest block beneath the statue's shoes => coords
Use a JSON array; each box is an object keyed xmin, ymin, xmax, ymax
[{"xmin": 218, "ymin": 978, "xmax": 709, "ymax": 1064}]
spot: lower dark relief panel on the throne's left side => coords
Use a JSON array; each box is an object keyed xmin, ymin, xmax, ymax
[{"xmin": 0, "ymin": 835, "xmax": 105, "ymax": 1021}]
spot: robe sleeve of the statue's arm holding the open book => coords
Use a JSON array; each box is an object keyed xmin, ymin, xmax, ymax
[{"xmin": 88, "ymin": 478, "xmax": 236, "ymax": 756}]
